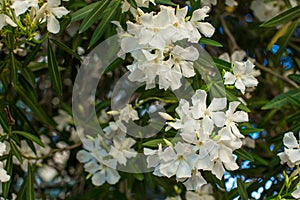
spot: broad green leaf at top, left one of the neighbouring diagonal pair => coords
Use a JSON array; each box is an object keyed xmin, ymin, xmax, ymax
[{"xmin": 79, "ymin": 0, "xmax": 111, "ymax": 34}]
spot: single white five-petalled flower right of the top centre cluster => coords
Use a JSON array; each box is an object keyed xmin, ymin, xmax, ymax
[{"xmin": 224, "ymin": 60, "xmax": 258, "ymax": 94}]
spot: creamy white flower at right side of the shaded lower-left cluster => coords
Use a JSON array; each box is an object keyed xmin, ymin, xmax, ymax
[{"xmin": 109, "ymin": 137, "xmax": 137, "ymax": 165}]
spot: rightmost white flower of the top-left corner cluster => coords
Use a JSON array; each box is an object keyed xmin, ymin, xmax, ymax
[{"xmin": 35, "ymin": 0, "xmax": 70, "ymax": 34}]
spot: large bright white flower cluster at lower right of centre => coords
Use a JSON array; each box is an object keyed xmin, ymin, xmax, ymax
[{"xmin": 144, "ymin": 90, "xmax": 248, "ymax": 190}]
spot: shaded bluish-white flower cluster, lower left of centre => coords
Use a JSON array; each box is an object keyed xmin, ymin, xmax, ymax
[{"xmin": 77, "ymin": 105, "xmax": 139, "ymax": 186}]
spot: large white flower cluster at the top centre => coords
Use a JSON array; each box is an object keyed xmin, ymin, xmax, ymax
[{"xmin": 118, "ymin": 6, "xmax": 215, "ymax": 90}]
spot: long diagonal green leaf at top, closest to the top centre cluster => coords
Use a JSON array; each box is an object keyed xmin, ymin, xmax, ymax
[{"xmin": 88, "ymin": 0, "xmax": 121, "ymax": 48}]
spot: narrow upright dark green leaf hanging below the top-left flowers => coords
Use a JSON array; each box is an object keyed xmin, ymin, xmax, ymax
[{"xmin": 48, "ymin": 40, "xmax": 62, "ymax": 95}]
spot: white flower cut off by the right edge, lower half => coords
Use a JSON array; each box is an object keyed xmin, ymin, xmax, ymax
[{"xmin": 277, "ymin": 132, "xmax": 300, "ymax": 167}]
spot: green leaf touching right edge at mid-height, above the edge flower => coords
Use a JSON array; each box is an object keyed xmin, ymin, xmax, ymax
[{"xmin": 261, "ymin": 89, "xmax": 300, "ymax": 110}]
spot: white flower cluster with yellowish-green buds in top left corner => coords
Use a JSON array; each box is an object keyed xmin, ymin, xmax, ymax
[{"xmin": 0, "ymin": 0, "xmax": 69, "ymax": 34}]
